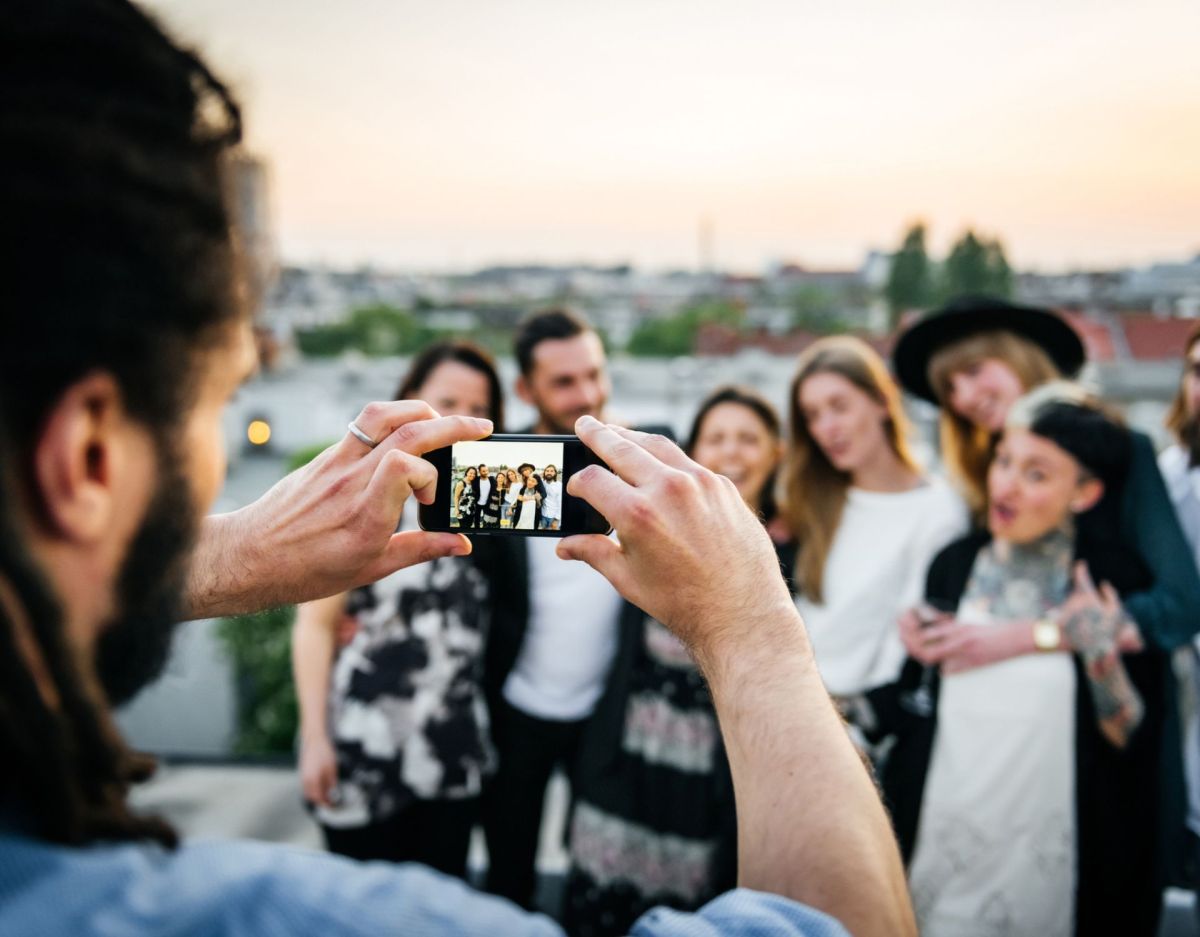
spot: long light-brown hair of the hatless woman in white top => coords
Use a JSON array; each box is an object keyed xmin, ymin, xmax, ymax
[{"xmin": 782, "ymin": 335, "xmax": 920, "ymax": 602}]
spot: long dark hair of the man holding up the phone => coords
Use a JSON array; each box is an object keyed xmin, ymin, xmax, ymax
[{"xmin": 0, "ymin": 0, "xmax": 244, "ymax": 842}]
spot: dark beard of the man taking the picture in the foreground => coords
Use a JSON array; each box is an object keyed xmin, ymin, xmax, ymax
[{"xmin": 96, "ymin": 446, "xmax": 199, "ymax": 705}]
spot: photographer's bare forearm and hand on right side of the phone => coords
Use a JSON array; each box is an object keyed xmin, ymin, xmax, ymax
[{"xmin": 559, "ymin": 418, "xmax": 916, "ymax": 937}]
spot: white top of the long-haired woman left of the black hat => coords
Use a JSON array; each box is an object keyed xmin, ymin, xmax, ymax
[{"xmin": 796, "ymin": 477, "xmax": 968, "ymax": 696}]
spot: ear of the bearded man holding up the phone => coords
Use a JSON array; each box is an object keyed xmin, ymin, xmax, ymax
[{"xmin": 34, "ymin": 374, "xmax": 127, "ymax": 542}]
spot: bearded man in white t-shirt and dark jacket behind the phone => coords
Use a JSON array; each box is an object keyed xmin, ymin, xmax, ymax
[{"xmin": 475, "ymin": 310, "xmax": 623, "ymax": 907}]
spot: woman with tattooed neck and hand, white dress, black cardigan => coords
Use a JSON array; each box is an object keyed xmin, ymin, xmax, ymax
[{"xmin": 869, "ymin": 384, "xmax": 1166, "ymax": 937}]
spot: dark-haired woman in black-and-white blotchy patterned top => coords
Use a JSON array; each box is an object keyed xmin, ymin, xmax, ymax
[{"xmin": 293, "ymin": 342, "xmax": 502, "ymax": 877}]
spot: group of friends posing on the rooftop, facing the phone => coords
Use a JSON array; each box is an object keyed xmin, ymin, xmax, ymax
[{"xmin": 288, "ymin": 298, "xmax": 1200, "ymax": 935}]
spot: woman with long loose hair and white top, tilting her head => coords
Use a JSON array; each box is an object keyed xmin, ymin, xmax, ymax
[{"xmin": 784, "ymin": 336, "xmax": 967, "ymax": 698}]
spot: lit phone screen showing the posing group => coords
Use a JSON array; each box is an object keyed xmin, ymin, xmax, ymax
[{"xmin": 449, "ymin": 440, "xmax": 563, "ymax": 530}]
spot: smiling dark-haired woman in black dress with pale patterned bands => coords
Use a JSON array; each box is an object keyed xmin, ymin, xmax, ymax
[{"xmin": 564, "ymin": 388, "xmax": 794, "ymax": 937}]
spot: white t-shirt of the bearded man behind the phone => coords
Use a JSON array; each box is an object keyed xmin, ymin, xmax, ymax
[{"xmin": 504, "ymin": 537, "xmax": 622, "ymax": 722}]
